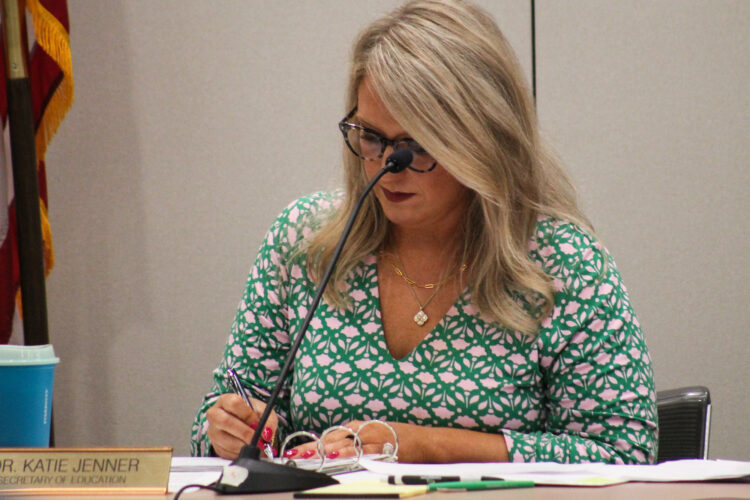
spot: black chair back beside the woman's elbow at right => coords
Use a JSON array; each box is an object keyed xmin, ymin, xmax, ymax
[{"xmin": 656, "ymin": 386, "xmax": 711, "ymax": 463}]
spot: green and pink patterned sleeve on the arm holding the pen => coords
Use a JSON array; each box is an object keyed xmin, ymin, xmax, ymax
[{"xmin": 190, "ymin": 201, "xmax": 318, "ymax": 456}]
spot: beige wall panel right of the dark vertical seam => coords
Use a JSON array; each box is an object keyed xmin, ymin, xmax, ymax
[{"xmin": 537, "ymin": 0, "xmax": 750, "ymax": 459}]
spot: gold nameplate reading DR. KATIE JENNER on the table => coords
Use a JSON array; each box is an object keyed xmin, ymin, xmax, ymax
[{"xmin": 0, "ymin": 447, "xmax": 172, "ymax": 494}]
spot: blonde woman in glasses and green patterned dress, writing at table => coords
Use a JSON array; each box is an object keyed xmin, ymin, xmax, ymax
[{"xmin": 192, "ymin": 0, "xmax": 656, "ymax": 463}]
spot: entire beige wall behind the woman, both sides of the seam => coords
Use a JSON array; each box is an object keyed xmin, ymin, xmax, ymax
[{"xmin": 48, "ymin": 0, "xmax": 750, "ymax": 459}]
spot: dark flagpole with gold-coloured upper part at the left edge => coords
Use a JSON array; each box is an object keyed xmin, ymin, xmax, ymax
[{"xmin": 2, "ymin": 0, "xmax": 49, "ymax": 345}]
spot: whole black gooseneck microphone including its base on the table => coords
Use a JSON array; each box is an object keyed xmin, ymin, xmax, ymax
[{"xmin": 213, "ymin": 149, "xmax": 414, "ymax": 494}]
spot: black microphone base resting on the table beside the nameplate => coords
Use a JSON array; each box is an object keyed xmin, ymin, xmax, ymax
[{"xmin": 213, "ymin": 457, "xmax": 338, "ymax": 495}]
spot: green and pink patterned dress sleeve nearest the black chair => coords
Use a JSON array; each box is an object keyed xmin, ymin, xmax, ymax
[{"xmin": 503, "ymin": 225, "xmax": 657, "ymax": 464}]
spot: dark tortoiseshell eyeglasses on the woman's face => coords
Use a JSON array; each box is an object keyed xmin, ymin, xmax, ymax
[{"xmin": 339, "ymin": 107, "xmax": 437, "ymax": 174}]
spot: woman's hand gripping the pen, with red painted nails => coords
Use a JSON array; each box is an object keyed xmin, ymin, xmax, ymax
[{"xmin": 206, "ymin": 394, "xmax": 278, "ymax": 460}]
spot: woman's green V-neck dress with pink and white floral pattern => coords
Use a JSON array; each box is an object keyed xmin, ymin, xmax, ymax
[{"xmin": 191, "ymin": 193, "xmax": 657, "ymax": 463}]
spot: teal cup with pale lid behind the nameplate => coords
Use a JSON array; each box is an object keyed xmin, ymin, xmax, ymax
[{"xmin": 0, "ymin": 344, "xmax": 60, "ymax": 448}]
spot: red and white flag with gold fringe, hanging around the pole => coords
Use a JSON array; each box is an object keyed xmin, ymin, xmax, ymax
[{"xmin": 0, "ymin": 0, "xmax": 73, "ymax": 344}]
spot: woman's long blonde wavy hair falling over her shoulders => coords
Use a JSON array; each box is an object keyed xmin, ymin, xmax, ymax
[{"xmin": 308, "ymin": 0, "xmax": 591, "ymax": 335}]
